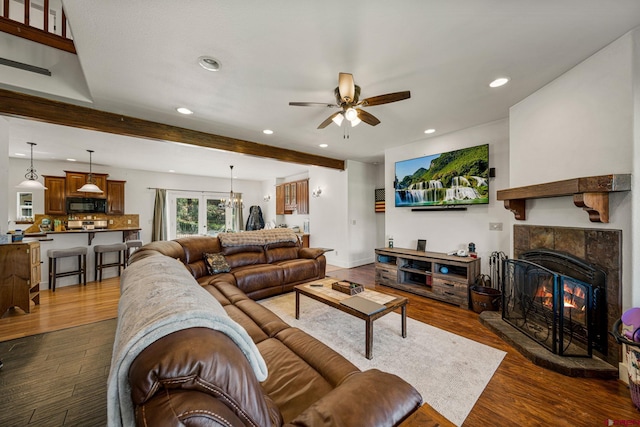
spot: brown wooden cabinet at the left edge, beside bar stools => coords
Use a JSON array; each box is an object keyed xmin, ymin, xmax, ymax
[{"xmin": 0, "ymin": 242, "xmax": 40, "ymax": 316}]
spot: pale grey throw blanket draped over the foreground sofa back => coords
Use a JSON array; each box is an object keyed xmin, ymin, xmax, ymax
[{"xmin": 107, "ymin": 256, "xmax": 267, "ymax": 426}]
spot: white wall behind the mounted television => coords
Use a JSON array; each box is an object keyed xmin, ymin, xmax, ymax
[{"xmin": 385, "ymin": 119, "xmax": 513, "ymax": 274}]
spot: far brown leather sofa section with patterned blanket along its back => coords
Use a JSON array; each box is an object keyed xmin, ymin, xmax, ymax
[{"xmin": 130, "ymin": 229, "xmax": 327, "ymax": 300}]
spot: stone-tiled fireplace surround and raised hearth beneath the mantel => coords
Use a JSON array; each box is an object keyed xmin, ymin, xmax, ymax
[{"xmin": 479, "ymin": 224, "xmax": 622, "ymax": 378}]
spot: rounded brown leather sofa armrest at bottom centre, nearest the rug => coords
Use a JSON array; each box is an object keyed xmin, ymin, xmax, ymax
[{"xmin": 287, "ymin": 369, "xmax": 422, "ymax": 427}]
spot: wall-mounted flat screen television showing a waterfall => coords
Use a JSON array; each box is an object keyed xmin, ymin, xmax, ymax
[{"xmin": 393, "ymin": 144, "xmax": 489, "ymax": 208}]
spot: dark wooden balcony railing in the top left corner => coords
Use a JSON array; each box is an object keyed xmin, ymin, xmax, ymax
[{"xmin": 0, "ymin": 0, "xmax": 76, "ymax": 53}]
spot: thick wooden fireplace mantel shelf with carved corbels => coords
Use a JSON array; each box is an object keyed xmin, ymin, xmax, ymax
[{"xmin": 497, "ymin": 174, "xmax": 631, "ymax": 223}]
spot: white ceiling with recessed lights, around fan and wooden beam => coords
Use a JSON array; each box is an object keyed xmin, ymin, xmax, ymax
[{"xmin": 0, "ymin": 0, "xmax": 640, "ymax": 179}]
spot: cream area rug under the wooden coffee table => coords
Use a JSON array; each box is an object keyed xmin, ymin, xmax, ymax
[{"xmin": 260, "ymin": 293, "xmax": 506, "ymax": 426}]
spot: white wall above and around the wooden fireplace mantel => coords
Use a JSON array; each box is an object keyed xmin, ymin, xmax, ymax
[{"xmin": 510, "ymin": 30, "xmax": 640, "ymax": 309}]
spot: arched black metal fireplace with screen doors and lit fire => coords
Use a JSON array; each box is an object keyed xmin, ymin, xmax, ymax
[{"xmin": 502, "ymin": 249, "xmax": 608, "ymax": 357}]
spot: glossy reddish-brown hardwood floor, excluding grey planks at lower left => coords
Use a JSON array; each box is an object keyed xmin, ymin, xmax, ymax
[{"xmin": 0, "ymin": 264, "xmax": 640, "ymax": 427}]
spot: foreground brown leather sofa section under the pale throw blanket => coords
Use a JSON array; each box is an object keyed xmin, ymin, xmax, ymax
[{"xmin": 118, "ymin": 232, "xmax": 422, "ymax": 427}]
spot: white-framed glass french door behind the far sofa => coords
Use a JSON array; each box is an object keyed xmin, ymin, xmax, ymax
[{"xmin": 169, "ymin": 191, "xmax": 227, "ymax": 240}]
